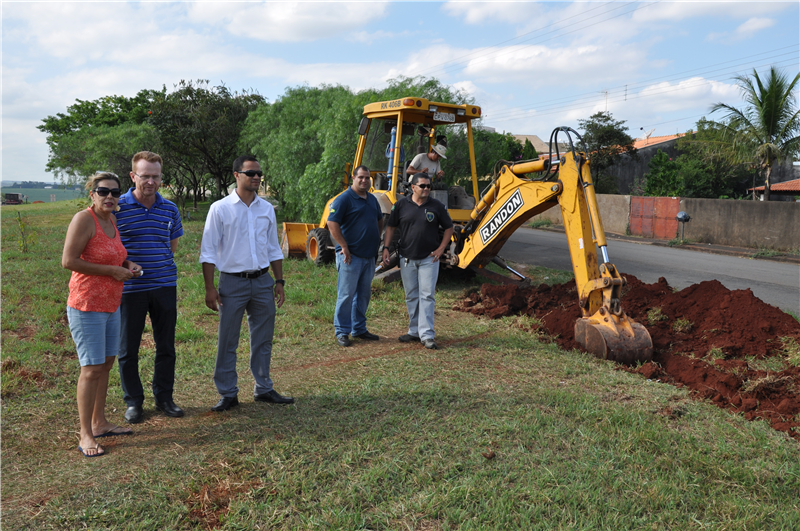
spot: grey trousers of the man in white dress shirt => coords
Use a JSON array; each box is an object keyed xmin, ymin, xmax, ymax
[{"xmin": 214, "ymin": 273, "xmax": 276, "ymax": 397}]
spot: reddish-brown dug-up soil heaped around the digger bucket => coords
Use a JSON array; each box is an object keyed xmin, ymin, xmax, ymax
[{"xmin": 454, "ymin": 275, "xmax": 800, "ymax": 439}]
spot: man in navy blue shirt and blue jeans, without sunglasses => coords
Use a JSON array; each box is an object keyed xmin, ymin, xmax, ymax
[{"xmin": 328, "ymin": 166, "xmax": 383, "ymax": 347}]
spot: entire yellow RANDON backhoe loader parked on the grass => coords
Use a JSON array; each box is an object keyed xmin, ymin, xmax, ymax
[{"xmin": 282, "ymin": 97, "xmax": 653, "ymax": 364}]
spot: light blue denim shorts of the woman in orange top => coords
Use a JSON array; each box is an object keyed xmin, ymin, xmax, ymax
[{"xmin": 67, "ymin": 306, "xmax": 120, "ymax": 367}]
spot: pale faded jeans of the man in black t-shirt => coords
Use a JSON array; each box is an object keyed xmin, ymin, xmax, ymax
[{"xmin": 400, "ymin": 256, "xmax": 439, "ymax": 341}]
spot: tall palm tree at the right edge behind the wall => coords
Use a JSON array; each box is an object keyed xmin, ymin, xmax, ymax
[{"xmin": 711, "ymin": 66, "xmax": 800, "ymax": 201}]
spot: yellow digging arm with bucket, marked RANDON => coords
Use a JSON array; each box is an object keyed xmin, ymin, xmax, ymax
[{"xmin": 450, "ymin": 128, "xmax": 653, "ymax": 364}]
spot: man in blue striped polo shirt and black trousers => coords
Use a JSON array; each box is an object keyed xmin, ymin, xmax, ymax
[{"xmin": 117, "ymin": 151, "xmax": 183, "ymax": 424}]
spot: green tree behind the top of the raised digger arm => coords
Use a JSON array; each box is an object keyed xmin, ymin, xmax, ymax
[{"xmin": 578, "ymin": 111, "xmax": 636, "ymax": 191}]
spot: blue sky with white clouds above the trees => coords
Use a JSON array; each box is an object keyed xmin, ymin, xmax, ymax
[{"xmin": 0, "ymin": 0, "xmax": 800, "ymax": 181}]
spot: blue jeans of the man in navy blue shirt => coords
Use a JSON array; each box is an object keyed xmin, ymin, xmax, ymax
[{"xmin": 333, "ymin": 253, "xmax": 375, "ymax": 337}]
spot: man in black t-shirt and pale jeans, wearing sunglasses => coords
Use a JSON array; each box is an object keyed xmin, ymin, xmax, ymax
[{"xmin": 383, "ymin": 173, "xmax": 453, "ymax": 349}]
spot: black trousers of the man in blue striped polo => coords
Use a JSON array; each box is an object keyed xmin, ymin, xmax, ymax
[{"xmin": 119, "ymin": 286, "xmax": 178, "ymax": 406}]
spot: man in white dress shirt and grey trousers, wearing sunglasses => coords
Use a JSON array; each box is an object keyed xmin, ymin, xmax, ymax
[{"xmin": 200, "ymin": 155, "xmax": 294, "ymax": 411}]
